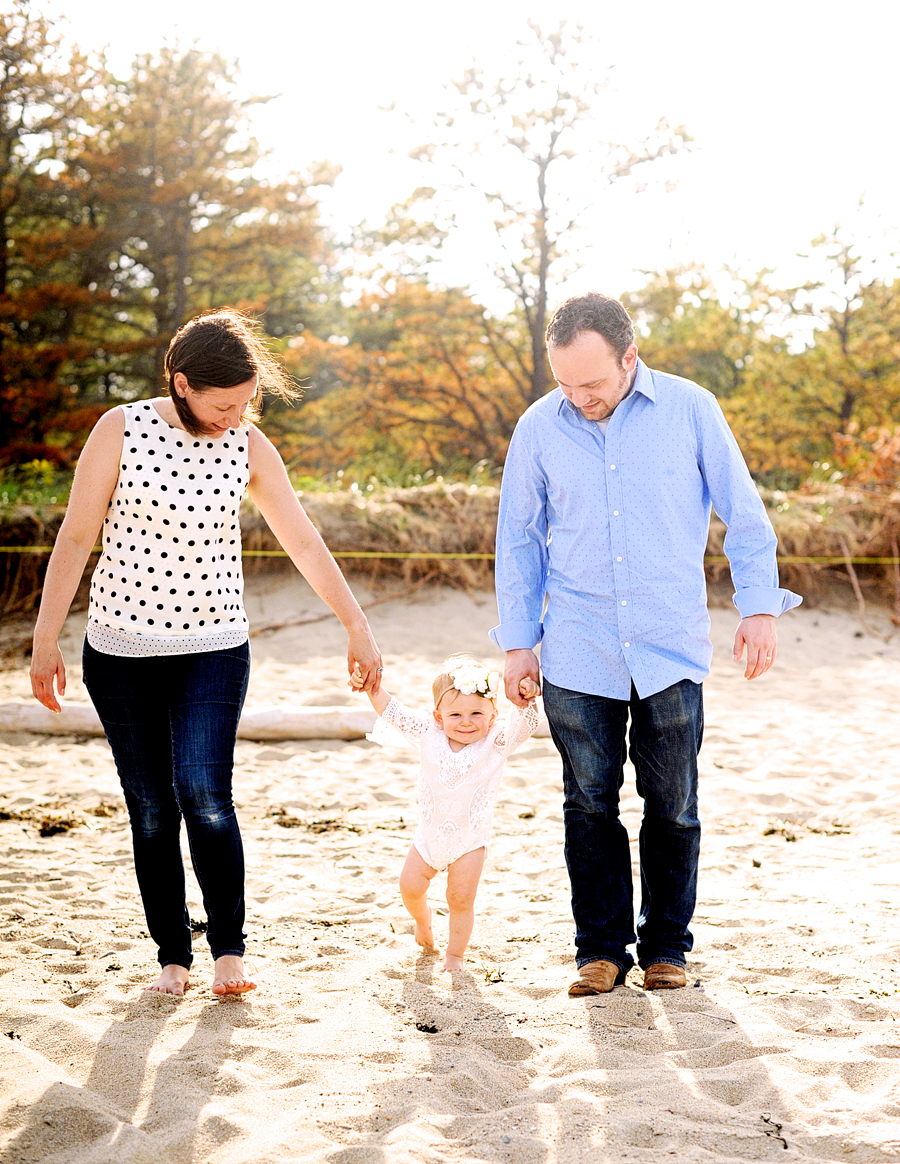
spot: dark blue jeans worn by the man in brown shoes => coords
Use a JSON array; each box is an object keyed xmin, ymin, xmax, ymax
[{"xmin": 543, "ymin": 679, "xmax": 703, "ymax": 972}]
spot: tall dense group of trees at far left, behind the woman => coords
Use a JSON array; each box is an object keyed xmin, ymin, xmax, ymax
[{"xmin": 0, "ymin": 33, "xmax": 339, "ymax": 461}]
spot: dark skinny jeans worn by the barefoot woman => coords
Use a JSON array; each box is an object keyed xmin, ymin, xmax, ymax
[{"xmin": 83, "ymin": 640, "xmax": 250, "ymax": 968}]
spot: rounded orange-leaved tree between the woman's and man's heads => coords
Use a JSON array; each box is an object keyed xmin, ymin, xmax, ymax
[{"xmin": 278, "ymin": 281, "xmax": 519, "ymax": 480}]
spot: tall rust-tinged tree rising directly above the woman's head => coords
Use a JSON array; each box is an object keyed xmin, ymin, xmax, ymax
[{"xmin": 69, "ymin": 47, "xmax": 334, "ymax": 390}]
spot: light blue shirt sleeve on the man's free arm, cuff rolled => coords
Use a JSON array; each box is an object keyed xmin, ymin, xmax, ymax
[{"xmin": 696, "ymin": 396, "xmax": 803, "ymax": 618}]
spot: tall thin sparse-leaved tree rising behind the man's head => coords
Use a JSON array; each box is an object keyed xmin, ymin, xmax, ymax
[{"xmin": 402, "ymin": 21, "xmax": 689, "ymax": 404}]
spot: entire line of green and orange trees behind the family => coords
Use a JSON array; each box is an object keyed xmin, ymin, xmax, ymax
[{"xmin": 0, "ymin": 0, "xmax": 900, "ymax": 490}]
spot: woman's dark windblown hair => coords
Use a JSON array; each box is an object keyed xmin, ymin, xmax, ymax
[{"xmin": 165, "ymin": 307, "xmax": 300, "ymax": 437}]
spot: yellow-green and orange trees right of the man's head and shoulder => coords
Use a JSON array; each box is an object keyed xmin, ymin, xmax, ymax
[{"xmin": 626, "ymin": 246, "xmax": 900, "ymax": 488}]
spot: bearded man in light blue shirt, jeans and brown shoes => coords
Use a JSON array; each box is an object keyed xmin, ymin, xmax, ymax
[{"xmin": 491, "ymin": 293, "xmax": 801, "ymax": 995}]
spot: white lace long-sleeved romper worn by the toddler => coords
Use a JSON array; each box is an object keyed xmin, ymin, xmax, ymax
[{"xmin": 369, "ymin": 700, "xmax": 538, "ymax": 871}]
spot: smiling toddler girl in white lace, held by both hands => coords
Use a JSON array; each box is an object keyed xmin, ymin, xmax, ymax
[{"xmin": 350, "ymin": 655, "xmax": 539, "ymax": 971}]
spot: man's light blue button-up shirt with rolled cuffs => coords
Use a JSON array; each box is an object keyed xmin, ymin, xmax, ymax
[{"xmin": 490, "ymin": 361, "xmax": 802, "ymax": 700}]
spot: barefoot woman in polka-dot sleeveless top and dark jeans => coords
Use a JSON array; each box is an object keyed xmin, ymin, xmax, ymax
[{"xmin": 31, "ymin": 310, "xmax": 382, "ymax": 995}]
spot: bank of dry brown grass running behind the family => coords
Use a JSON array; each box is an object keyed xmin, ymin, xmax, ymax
[{"xmin": 7, "ymin": 484, "xmax": 900, "ymax": 653}]
